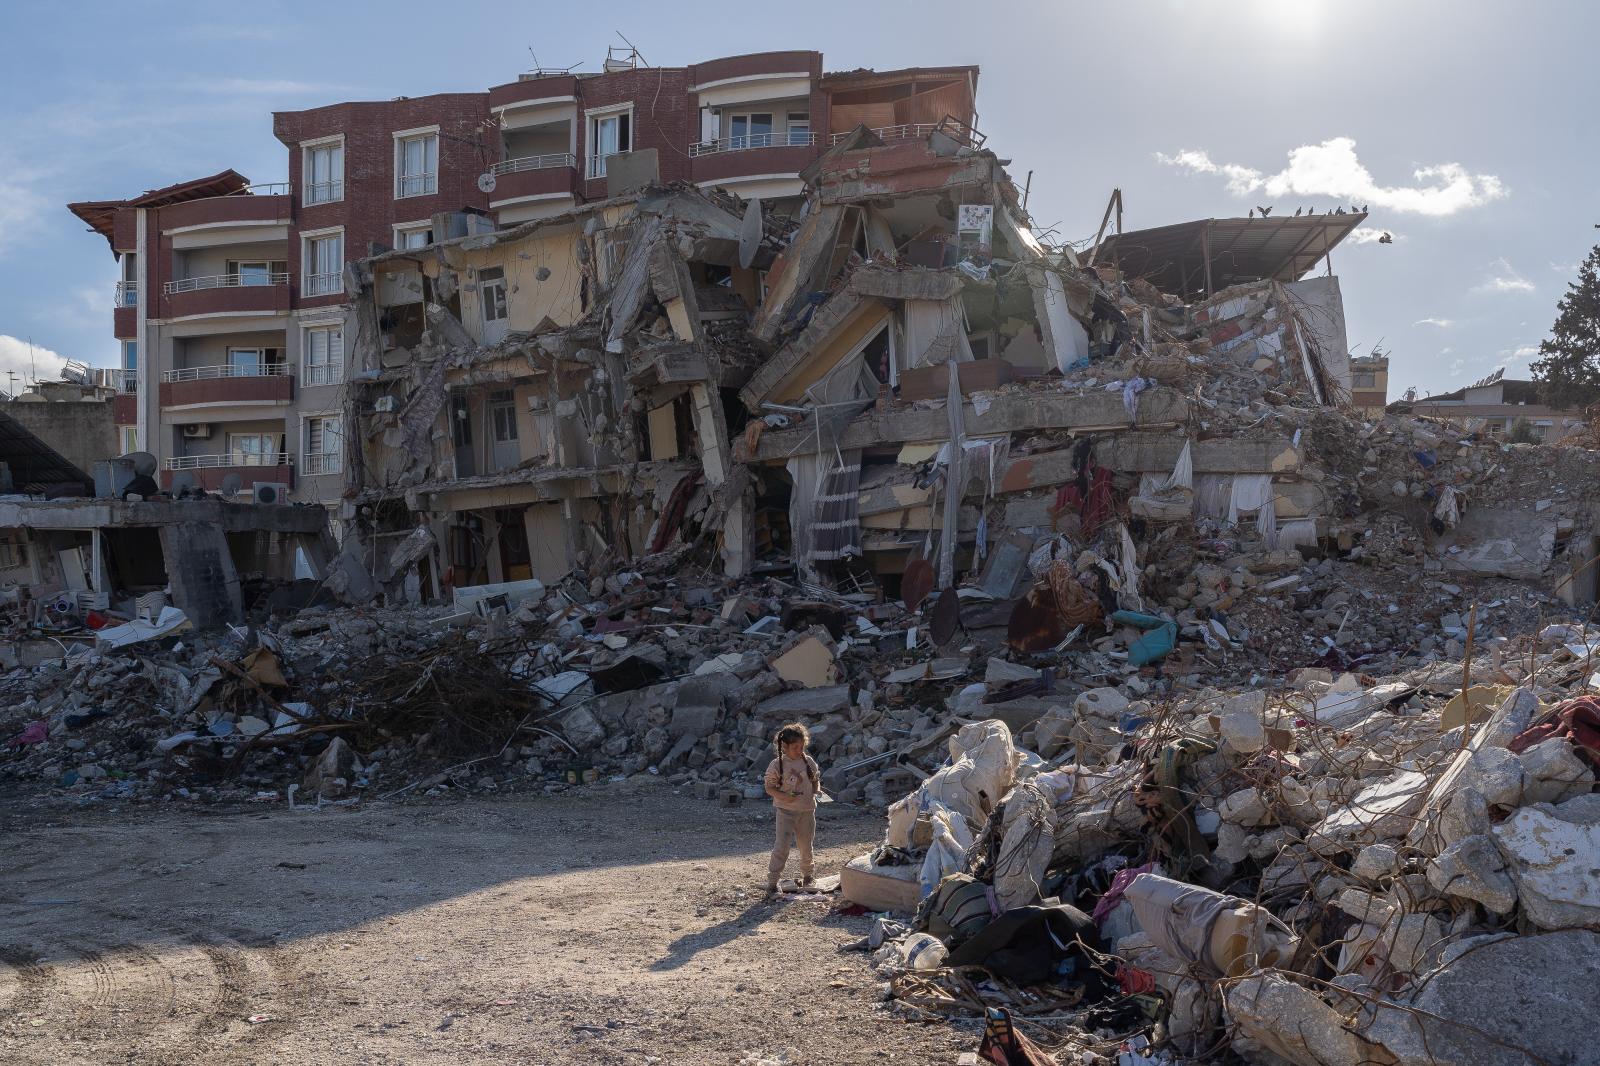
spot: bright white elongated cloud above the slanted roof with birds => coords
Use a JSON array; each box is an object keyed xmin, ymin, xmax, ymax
[{"xmin": 1155, "ymin": 138, "xmax": 1507, "ymax": 218}]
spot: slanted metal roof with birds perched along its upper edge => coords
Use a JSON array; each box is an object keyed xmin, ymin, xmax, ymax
[{"xmin": 1099, "ymin": 211, "xmax": 1366, "ymax": 299}]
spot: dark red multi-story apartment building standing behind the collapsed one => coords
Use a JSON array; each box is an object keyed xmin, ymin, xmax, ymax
[{"xmin": 69, "ymin": 51, "xmax": 978, "ymax": 531}]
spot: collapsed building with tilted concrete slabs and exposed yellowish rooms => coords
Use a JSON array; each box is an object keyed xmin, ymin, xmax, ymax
[{"xmin": 340, "ymin": 118, "xmax": 1401, "ymax": 599}]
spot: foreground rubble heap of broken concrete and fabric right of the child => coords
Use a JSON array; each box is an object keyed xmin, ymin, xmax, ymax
[{"xmin": 845, "ymin": 614, "xmax": 1600, "ymax": 1064}]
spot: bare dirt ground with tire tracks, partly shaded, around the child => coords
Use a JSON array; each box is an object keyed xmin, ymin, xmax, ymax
[{"xmin": 0, "ymin": 781, "xmax": 976, "ymax": 1066}]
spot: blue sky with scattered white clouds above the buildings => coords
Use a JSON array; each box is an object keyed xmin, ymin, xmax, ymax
[{"xmin": 0, "ymin": 0, "xmax": 1600, "ymax": 397}]
